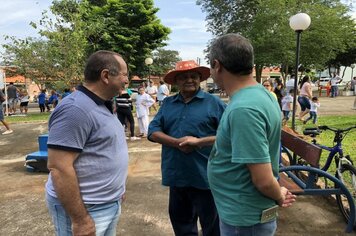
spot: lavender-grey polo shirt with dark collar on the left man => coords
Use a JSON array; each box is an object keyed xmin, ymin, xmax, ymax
[{"xmin": 46, "ymin": 86, "xmax": 129, "ymax": 204}]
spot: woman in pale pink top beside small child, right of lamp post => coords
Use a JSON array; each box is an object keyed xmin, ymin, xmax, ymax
[{"xmin": 298, "ymin": 75, "xmax": 313, "ymax": 121}]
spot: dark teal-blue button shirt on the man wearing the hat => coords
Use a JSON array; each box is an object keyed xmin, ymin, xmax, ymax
[{"xmin": 148, "ymin": 90, "xmax": 226, "ymax": 189}]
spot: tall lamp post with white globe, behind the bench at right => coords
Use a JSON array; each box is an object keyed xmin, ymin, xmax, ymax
[{"xmin": 289, "ymin": 13, "xmax": 311, "ymax": 131}]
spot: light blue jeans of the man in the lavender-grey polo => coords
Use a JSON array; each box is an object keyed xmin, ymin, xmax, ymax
[{"xmin": 46, "ymin": 194, "xmax": 121, "ymax": 236}]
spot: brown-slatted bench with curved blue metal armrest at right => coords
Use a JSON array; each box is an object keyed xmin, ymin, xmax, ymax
[{"xmin": 279, "ymin": 130, "xmax": 355, "ymax": 233}]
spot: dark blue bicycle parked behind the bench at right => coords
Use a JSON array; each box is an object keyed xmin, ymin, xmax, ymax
[{"xmin": 302, "ymin": 125, "xmax": 356, "ymax": 222}]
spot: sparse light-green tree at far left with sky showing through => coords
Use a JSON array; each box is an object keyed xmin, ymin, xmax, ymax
[{"xmin": 2, "ymin": 0, "xmax": 87, "ymax": 88}]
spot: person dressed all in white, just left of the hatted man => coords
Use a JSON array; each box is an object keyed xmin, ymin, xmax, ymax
[{"xmin": 136, "ymin": 87, "xmax": 155, "ymax": 138}]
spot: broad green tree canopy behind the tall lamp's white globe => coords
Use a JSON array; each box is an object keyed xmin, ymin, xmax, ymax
[{"xmin": 197, "ymin": 0, "xmax": 356, "ymax": 79}]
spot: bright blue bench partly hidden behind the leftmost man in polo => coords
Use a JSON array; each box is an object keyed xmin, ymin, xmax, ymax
[{"xmin": 25, "ymin": 134, "xmax": 49, "ymax": 173}]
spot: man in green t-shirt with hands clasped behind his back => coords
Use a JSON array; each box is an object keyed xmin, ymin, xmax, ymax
[{"xmin": 208, "ymin": 34, "xmax": 295, "ymax": 236}]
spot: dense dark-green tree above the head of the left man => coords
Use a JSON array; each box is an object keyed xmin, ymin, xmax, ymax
[{"xmin": 83, "ymin": 0, "xmax": 170, "ymax": 75}]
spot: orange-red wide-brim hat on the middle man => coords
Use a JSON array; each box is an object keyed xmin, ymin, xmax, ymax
[{"xmin": 163, "ymin": 60, "xmax": 210, "ymax": 84}]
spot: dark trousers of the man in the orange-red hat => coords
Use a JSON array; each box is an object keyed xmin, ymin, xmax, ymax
[{"xmin": 169, "ymin": 187, "xmax": 220, "ymax": 236}]
